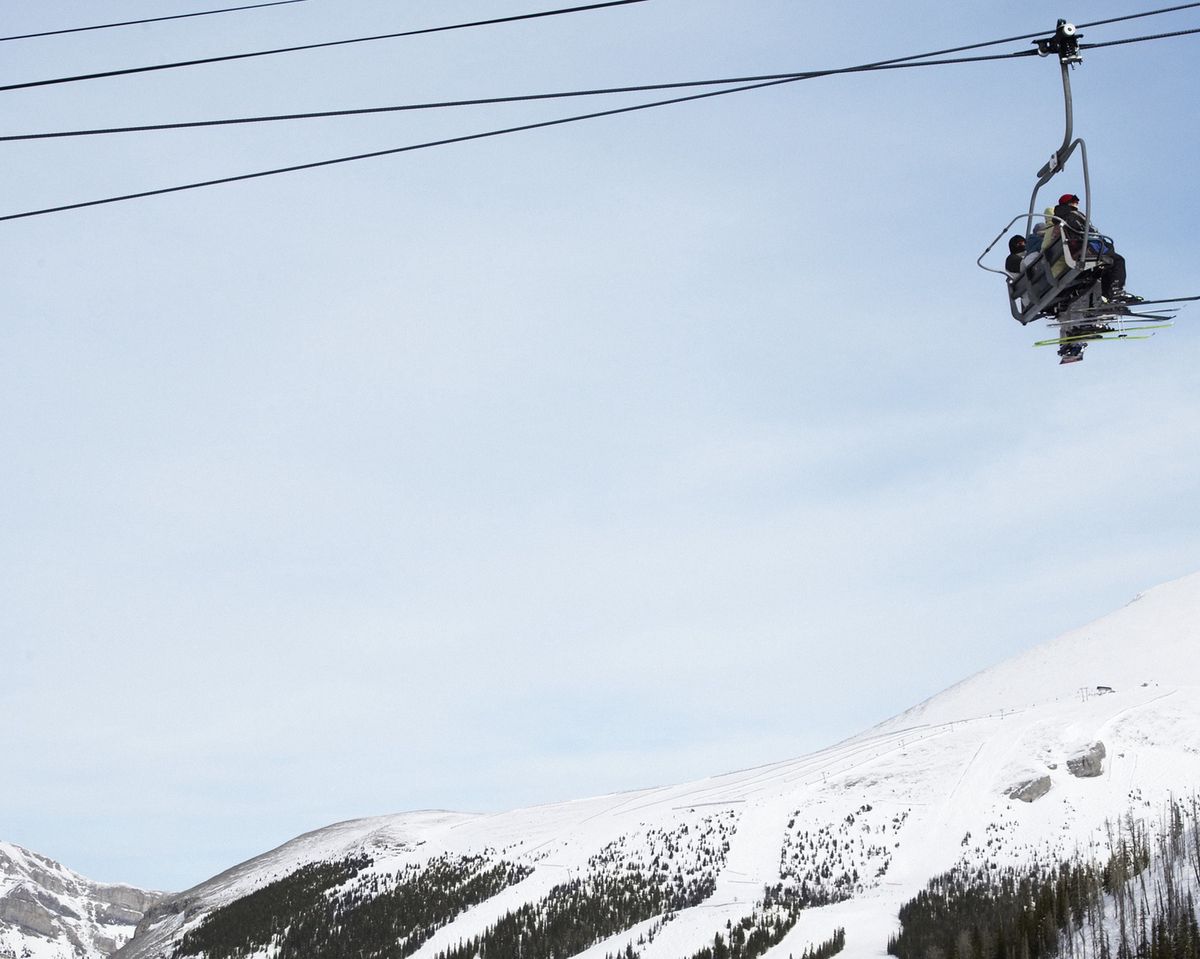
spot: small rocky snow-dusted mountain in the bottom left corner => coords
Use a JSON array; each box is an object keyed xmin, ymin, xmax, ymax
[{"xmin": 0, "ymin": 843, "xmax": 164, "ymax": 959}]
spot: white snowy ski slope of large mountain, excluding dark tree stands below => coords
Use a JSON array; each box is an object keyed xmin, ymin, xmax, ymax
[{"xmin": 120, "ymin": 575, "xmax": 1200, "ymax": 959}]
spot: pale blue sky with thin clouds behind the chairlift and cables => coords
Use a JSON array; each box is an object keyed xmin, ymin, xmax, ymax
[{"xmin": 0, "ymin": 0, "xmax": 1200, "ymax": 888}]
